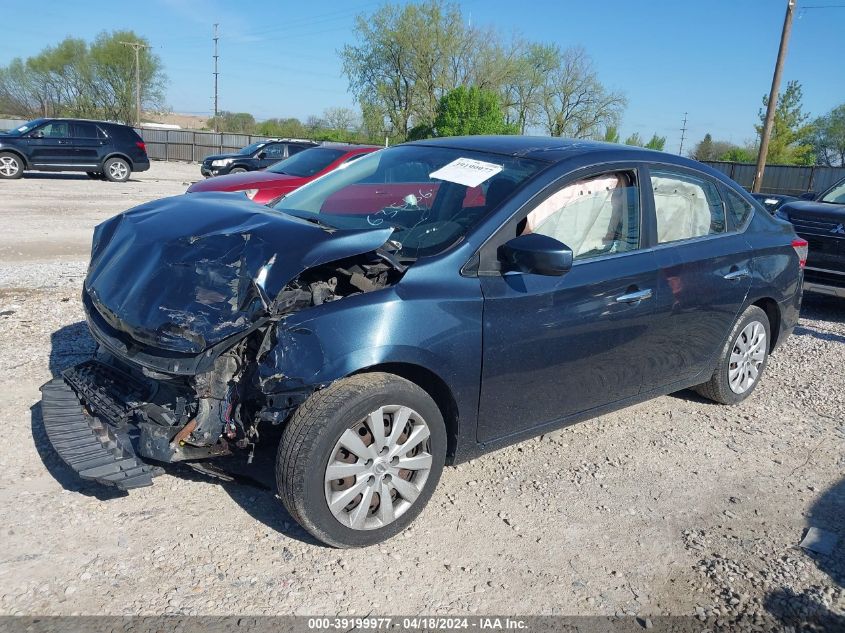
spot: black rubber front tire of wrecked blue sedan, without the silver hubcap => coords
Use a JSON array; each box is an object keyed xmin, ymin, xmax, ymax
[{"xmin": 276, "ymin": 373, "xmax": 446, "ymax": 547}]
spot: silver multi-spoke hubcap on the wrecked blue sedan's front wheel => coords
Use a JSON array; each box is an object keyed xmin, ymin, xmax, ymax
[{"xmin": 324, "ymin": 405, "xmax": 432, "ymax": 530}]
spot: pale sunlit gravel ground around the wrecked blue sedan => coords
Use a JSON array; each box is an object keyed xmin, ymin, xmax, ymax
[{"xmin": 0, "ymin": 163, "xmax": 845, "ymax": 627}]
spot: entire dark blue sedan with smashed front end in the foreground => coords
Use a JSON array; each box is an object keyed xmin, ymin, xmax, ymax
[{"xmin": 42, "ymin": 137, "xmax": 806, "ymax": 547}]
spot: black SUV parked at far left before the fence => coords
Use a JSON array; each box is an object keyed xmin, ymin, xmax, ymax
[{"xmin": 0, "ymin": 119, "xmax": 150, "ymax": 182}]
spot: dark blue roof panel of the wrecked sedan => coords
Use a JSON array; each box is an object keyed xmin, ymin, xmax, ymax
[{"xmin": 406, "ymin": 136, "xmax": 712, "ymax": 172}]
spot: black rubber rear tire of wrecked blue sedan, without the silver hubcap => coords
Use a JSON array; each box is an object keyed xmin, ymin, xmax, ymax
[{"xmin": 694, "ymin": 306, "xmax": 772, "ymax": 404}]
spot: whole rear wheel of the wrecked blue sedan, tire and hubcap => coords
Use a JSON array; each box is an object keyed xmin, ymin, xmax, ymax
[{"xmin": 695, "ymin": 306, "xmax": 771, "ymax": 404}]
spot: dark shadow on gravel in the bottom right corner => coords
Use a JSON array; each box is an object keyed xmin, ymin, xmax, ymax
[{"xmin": 763, "ymin": 478, "xmax": 845, "ymax": 631}]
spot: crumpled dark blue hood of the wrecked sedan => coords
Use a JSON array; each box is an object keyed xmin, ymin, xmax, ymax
[{"xmin": 84, "ymin": 193, "xmax": 392, "ymax": 353}]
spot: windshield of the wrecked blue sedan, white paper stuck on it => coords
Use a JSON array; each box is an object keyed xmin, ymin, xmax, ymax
[{"xmin": 273, "ymin": 145, "xmax": 545, "ymax": 259}]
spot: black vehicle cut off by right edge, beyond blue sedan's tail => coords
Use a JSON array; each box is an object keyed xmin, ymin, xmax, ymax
[{"xmin": 776, "ymin": 179, "xmax": 845, "ymax": 298}]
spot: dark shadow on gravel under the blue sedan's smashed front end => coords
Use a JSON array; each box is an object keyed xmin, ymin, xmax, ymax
[{"xmin": 39, "ymin": 321, "xmax": 325, "ymax": 547}]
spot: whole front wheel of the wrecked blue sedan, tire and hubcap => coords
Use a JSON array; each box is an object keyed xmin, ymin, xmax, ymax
[{"xmin": 276, "ymin": 373, "xmax": 446, "ymax": 547}]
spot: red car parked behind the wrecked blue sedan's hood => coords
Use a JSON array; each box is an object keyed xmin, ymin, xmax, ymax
[{"xmin": 187, "ymin": 145, "xmax": 380, "ymax": 204}]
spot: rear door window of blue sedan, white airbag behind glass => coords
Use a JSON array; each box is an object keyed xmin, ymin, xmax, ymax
[{"xmin": 650, "ymin": 169, "xmax": 727, "ymax": 244}]
